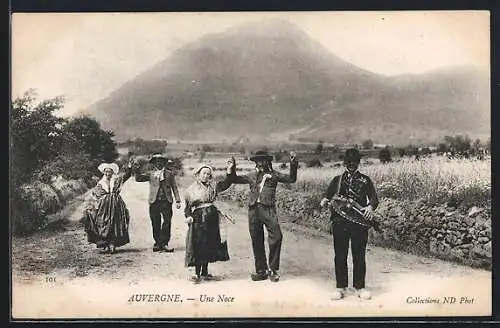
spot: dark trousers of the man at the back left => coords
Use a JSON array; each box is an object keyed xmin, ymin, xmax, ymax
[{"xmin": 149, "ymin": 200, "xmax": 172, "ymax": 246}]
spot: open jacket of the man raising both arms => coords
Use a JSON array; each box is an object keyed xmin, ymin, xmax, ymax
[{"xmin": 232, "ymin": 162, "xmax": 298, "ymax": 207}]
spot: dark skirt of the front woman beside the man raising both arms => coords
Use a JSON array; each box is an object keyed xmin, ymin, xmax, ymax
[{"xmin": 185, "ymin": 206, "xmax": 229, "ymax": 267}]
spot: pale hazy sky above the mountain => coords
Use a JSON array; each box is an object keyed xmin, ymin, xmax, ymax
[{"xmin": 11, "ymin": 11, "xmax": 490, "ymax": 116}]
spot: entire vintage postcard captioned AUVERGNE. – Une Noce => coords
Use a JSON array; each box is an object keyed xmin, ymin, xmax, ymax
[{"xmin": 10, "ymin": 11, "xmax": 492, "ymax": 320}]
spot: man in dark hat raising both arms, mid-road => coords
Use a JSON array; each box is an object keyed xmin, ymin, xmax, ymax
[{"xmin": 233, "ymin": 151, "xmax": 298, "ymax": 282}]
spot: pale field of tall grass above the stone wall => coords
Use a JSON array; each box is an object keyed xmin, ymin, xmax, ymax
[{"xmin": 184, "ymin": 154, "xmax": 491, "ymax": 207}]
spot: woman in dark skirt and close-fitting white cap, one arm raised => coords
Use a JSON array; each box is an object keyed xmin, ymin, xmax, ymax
[{"xmin": 184, "ymin": 158, "xmax": 236, "ymax": 283}]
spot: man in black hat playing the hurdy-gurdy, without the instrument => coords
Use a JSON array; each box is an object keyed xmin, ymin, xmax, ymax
[{"xmin": 321, "ymin": 148, "xmax": 378, "ymax": 300}]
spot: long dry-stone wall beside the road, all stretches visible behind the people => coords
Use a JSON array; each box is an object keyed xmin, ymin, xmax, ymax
[{"xmin": 219, "ymin": 186, "xmax": 492, "ymax": 270}]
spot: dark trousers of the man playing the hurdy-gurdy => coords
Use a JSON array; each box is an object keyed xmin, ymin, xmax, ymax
[{"xmin": 332, "ymin": 220, "xmax": 368, "ymax": 289}]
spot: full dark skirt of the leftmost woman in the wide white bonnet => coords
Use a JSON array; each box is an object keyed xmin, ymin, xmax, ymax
[{"xmin": 85, "ymin": 193, "xmax": 130, "ymax": 248}]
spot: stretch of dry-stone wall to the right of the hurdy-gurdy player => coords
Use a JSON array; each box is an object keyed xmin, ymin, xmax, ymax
[{"xmin": 370, "ymin": 198, "xmax": 492, "ymax": 269}]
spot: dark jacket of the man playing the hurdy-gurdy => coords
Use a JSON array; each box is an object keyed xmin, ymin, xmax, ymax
[{"xmin": 324, "ymin": 170, "xmax": 379, "ymax": 217}]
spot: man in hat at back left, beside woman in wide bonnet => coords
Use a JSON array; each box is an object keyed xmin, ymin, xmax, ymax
[{"xmin": 135, "ymin": 153, "xmax": 181, "ymax": 252}]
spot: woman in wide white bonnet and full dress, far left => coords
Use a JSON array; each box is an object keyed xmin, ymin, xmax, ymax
[{"xmin": 85, "ymin": 163, "xmax": 131, "ymax": 253}]
